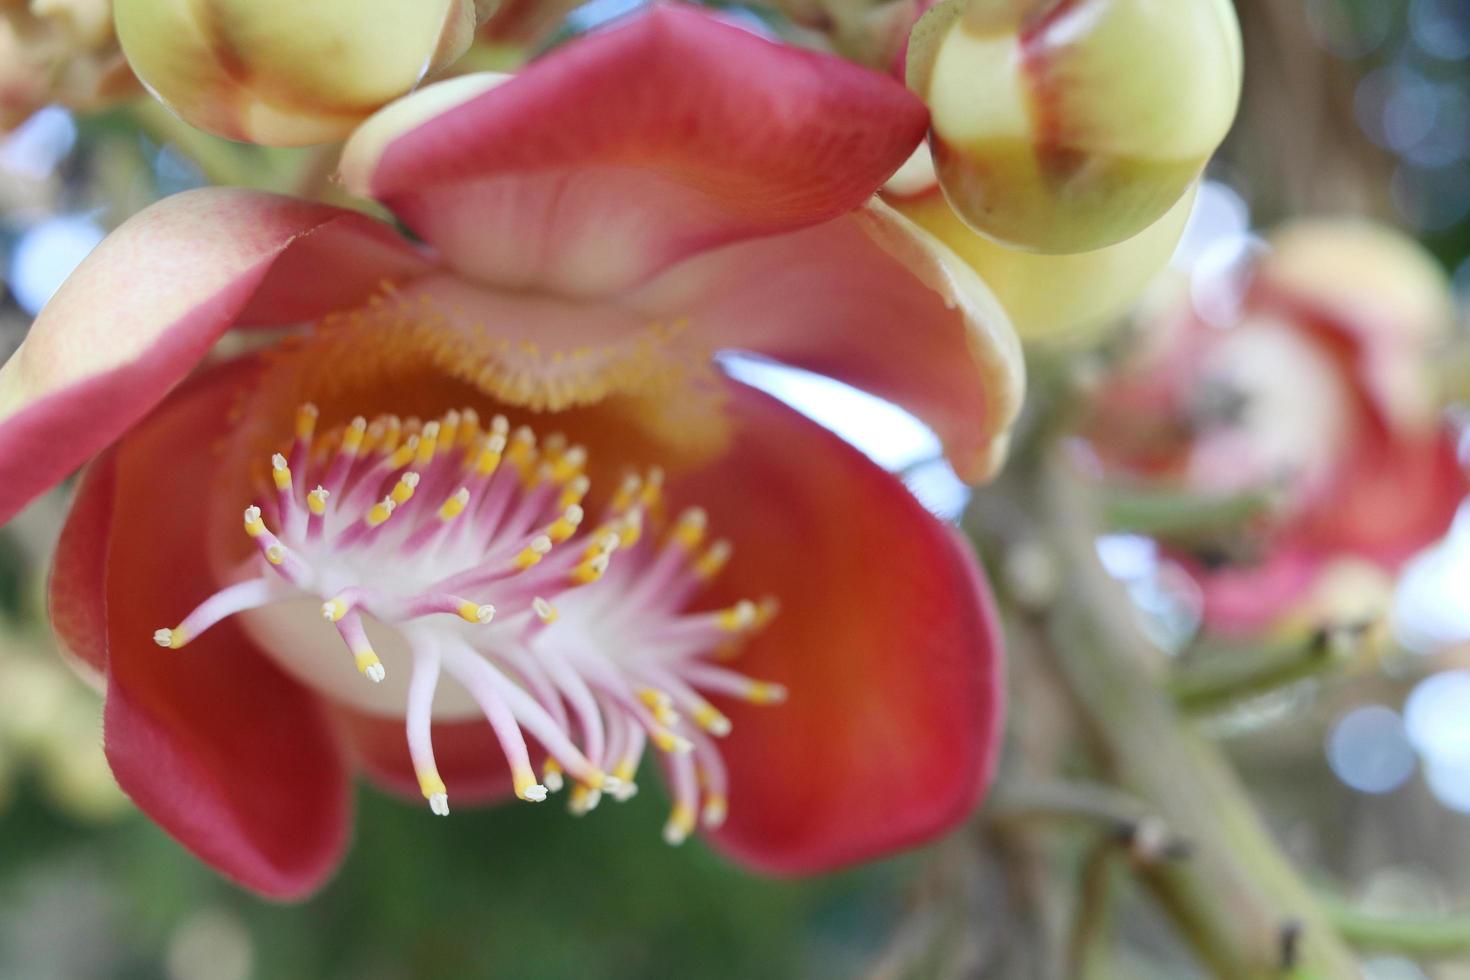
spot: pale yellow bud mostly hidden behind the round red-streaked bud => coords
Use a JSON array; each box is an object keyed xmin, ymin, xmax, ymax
[{"xmin": 891, "ymin": 179, "xmax": 1195, "ymax": 344}]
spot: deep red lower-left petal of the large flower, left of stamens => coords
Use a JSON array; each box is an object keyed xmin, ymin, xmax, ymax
[{"xmin": 51, "ymin": 358, "xmax": 348, "ymax": 898}]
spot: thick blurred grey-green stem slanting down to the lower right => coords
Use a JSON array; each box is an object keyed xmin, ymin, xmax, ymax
[{"xmin": 1032, "ymin": 457, "xmax": 1357, "ymax": 980}]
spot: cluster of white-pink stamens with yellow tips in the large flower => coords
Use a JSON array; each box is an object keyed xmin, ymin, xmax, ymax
[{"xmin": 153, "ymin": 406, "xmax": 785, "ymax": 843}]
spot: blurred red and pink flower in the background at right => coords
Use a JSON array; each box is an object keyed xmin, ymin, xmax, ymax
[{"xmin": 1089, "ymin": 220, "xmax": 1466, "ymax": 635}]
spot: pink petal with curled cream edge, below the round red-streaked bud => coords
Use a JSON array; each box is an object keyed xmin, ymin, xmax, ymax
[{"xmin": 632, "ymin": 200, "xmax": 1025, "ymax": 482}]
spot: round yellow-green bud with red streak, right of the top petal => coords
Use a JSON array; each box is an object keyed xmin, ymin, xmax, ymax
[{"xmin": 907, "ymin": 0, "xmax": 1241, "ymax": 253}]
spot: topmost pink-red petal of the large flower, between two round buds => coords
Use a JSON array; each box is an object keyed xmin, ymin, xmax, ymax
[{"xmin": 343, "ymin": 6, "xmax": 928, "ymax": 294}]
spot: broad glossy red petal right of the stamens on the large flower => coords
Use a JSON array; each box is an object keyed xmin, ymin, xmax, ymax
[{"xmin": 675, "ymin": 382, "xmax": 1001, "ymax": 873}]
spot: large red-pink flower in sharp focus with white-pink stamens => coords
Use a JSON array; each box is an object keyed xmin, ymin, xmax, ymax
[{"xmin": 0, "ymin": 7, "xmax": 1022, "ymax": 896}]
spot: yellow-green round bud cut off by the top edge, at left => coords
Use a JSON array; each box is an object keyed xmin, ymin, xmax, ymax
[{"xmin": 115, "ymin": 0, "xmax": 475, "ymax": 147}]
